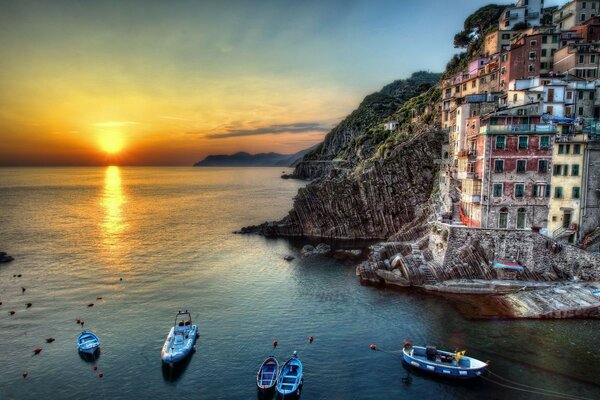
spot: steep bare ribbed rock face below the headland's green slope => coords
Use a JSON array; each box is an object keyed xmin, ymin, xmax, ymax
[{"xmin": 265, "ymin": 131, "xmax": 444, "ymax": 239}]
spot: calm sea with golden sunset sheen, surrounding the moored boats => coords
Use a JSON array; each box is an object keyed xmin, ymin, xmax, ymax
[{"xmin": 0, "ymin": 167, "xmax": 600, "ymax": 399}]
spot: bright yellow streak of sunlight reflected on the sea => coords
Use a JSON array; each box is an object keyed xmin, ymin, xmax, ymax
[{"xmin": 101, "ymin": 166, "xmax": 127, "ymax": 242}]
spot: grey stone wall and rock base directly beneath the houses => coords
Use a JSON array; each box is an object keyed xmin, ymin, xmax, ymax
[{"xmin": 438, "ymin": 224, "xmax": 600, "ymax": 281}]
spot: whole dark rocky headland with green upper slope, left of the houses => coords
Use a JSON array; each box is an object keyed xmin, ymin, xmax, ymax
[{"xmin": 243, "ymin": 73, "xmax": 445, "ymax": 239}]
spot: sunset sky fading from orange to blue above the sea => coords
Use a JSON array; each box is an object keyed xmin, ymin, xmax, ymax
[{"xmin": 0, "ymin": 0, "xmax": 559, "ymax": 165}]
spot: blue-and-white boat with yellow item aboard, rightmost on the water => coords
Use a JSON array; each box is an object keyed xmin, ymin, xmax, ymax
[{"xmin": 402, "ymin": 344, "xmax": 488, "ymax": 379}]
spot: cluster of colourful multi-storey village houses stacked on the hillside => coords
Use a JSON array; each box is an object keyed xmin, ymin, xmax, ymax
[{"xmin": 441, "ymin": 0, "xmax": 600, "ymax": 251}]
